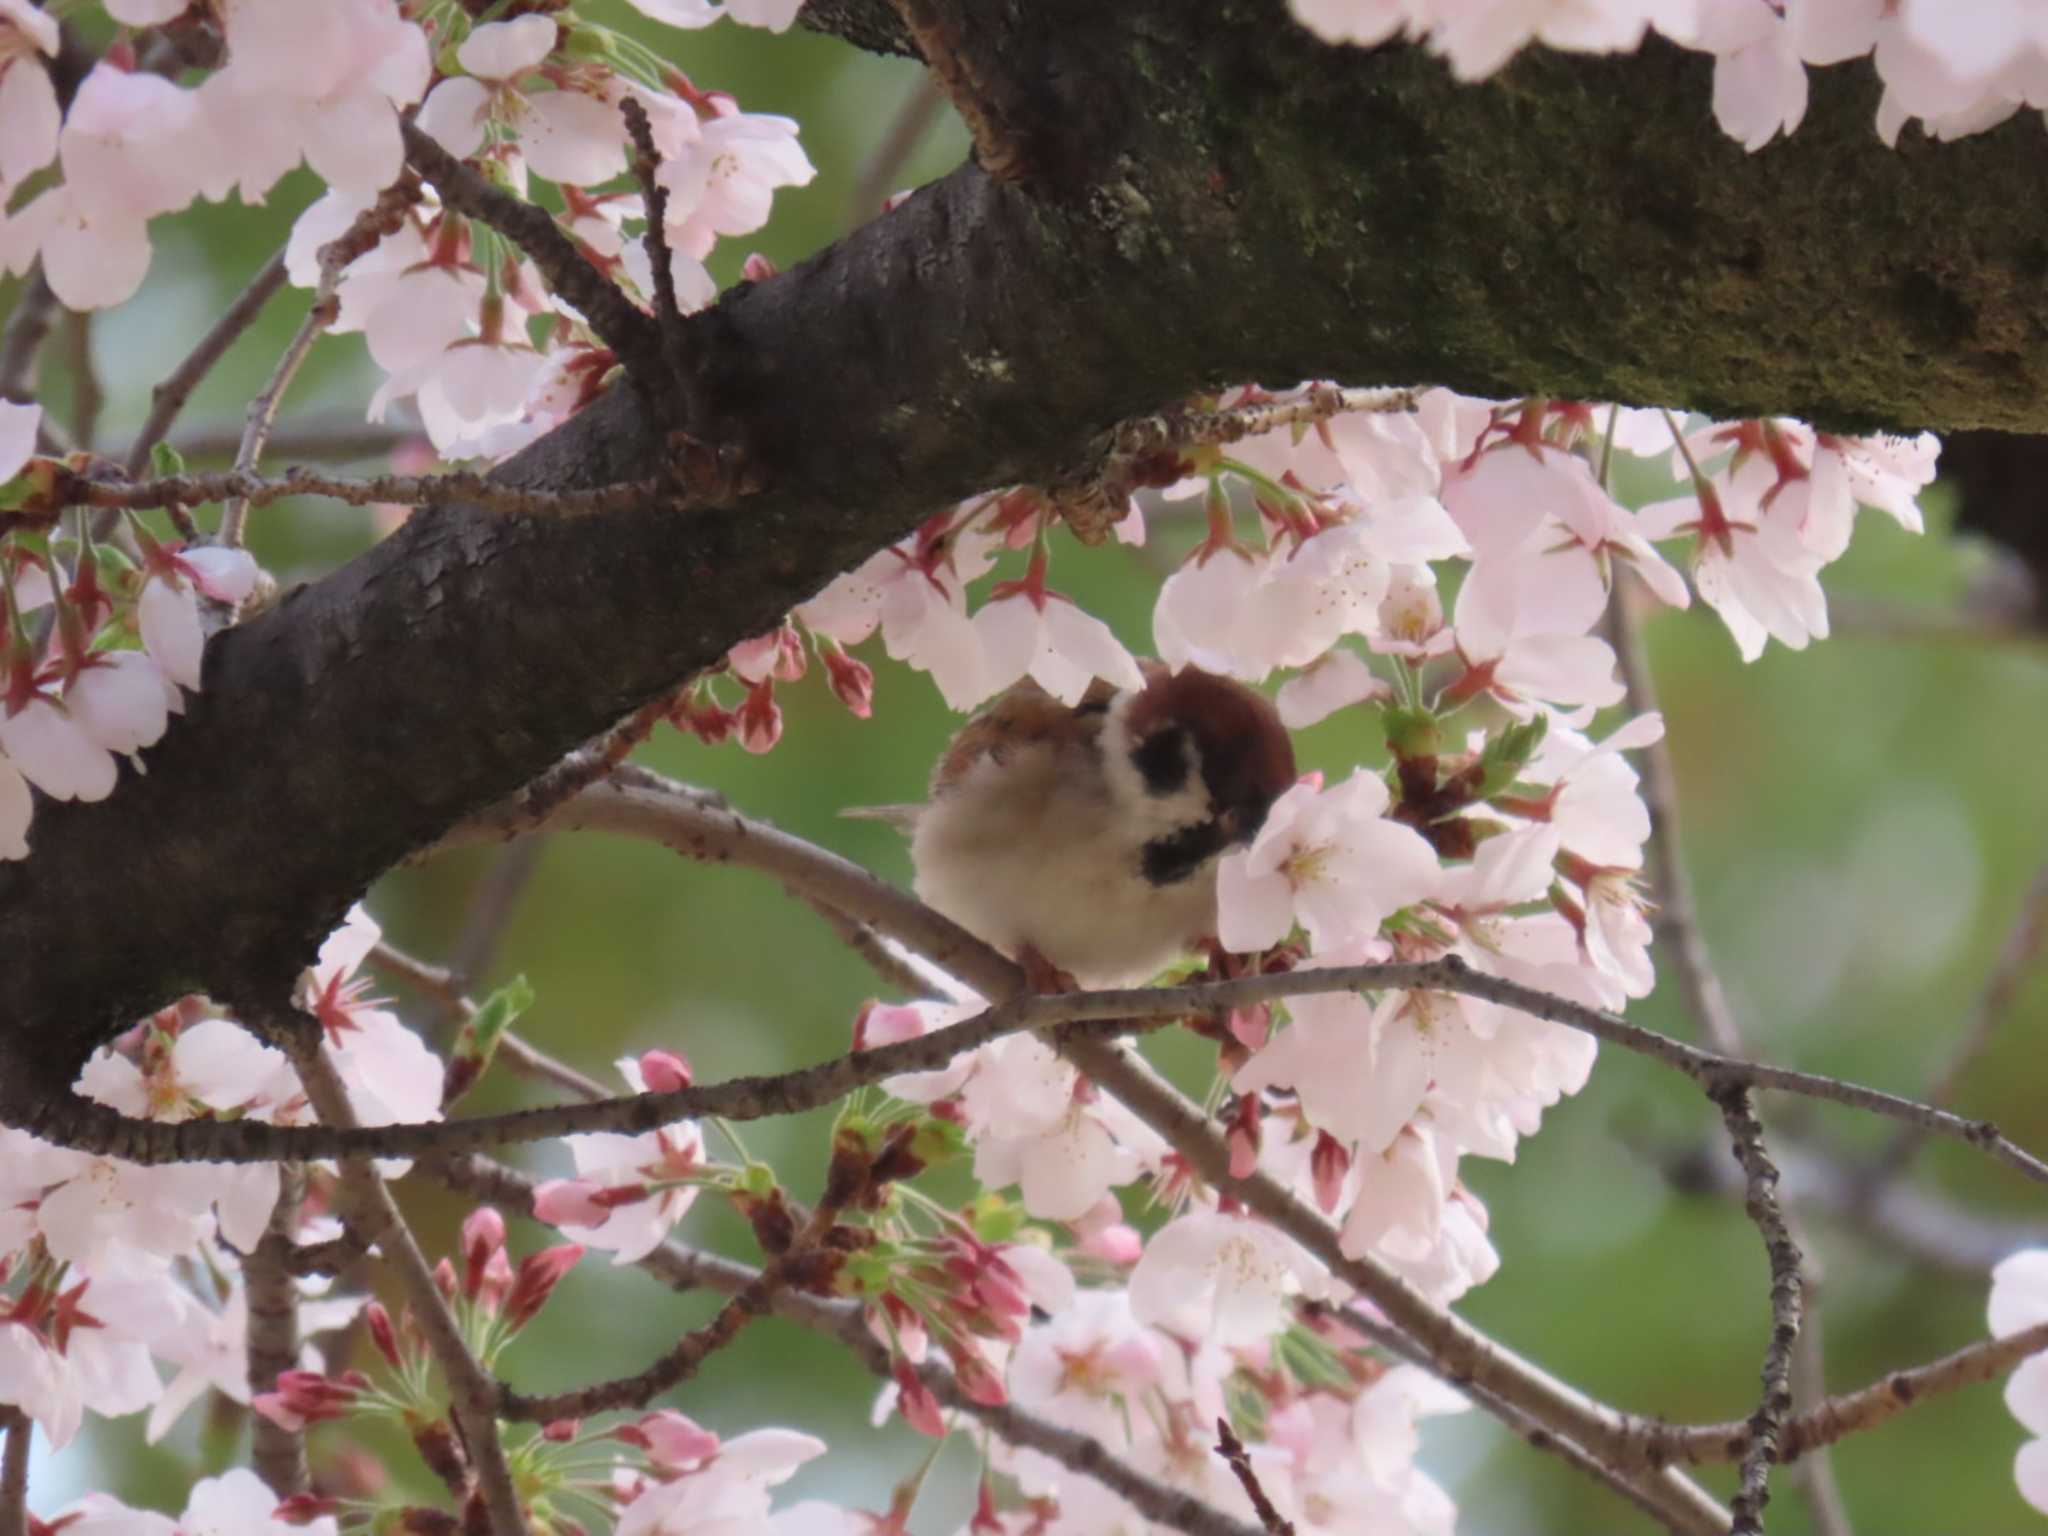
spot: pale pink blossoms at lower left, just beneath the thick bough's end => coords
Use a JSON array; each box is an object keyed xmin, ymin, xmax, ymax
[{"xmin": 0, "ymin": 909, "xmax": 440, "ymax": 1446}]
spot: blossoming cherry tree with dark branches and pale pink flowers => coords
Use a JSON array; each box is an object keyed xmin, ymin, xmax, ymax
[{"xmin": 0, "ymin": 0, "xmax": 2048, "ymax": 1536}]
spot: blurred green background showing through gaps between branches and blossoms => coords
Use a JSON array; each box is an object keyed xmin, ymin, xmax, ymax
[{"xmin": 12, "ymin": 4, "xmax": 2048, "ymax": 1536}]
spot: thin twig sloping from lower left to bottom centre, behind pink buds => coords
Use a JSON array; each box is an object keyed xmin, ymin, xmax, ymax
[{"xmin": 440, "ymin": 1157, "xmax": 1260, "ymax": 1536}]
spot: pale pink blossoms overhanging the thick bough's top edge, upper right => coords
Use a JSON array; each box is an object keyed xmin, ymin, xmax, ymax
[{"xmin": 1290, "ymin": 0, "xmax": 2048, "ymax": 150}]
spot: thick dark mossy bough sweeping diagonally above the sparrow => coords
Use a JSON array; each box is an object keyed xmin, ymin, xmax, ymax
[{"xmin": 0, "ymin": 0, "xmax": 2048, "ymax": 1116}]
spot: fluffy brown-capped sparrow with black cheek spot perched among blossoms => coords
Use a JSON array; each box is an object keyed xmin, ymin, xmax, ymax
[{"xmin": 864, "ymin": 662, "xmax": 1294, "ymax": 987}]
